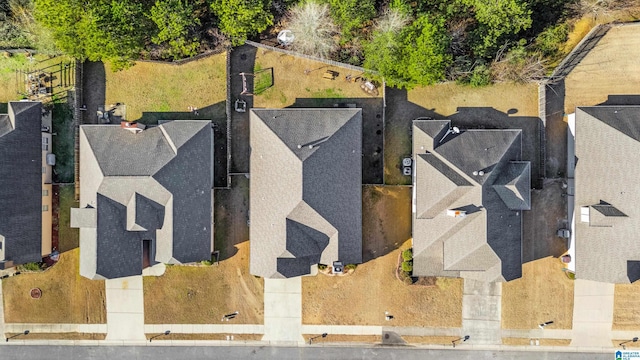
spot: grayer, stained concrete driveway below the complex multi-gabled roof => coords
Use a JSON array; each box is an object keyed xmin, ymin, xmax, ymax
[{"xmin": 462, "ymin": 279, "xmax": 502, "ymax": 345}]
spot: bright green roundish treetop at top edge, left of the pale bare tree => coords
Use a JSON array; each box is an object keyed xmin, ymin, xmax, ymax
[{"xmin": 211, "ymin": 0, "xmax": 273, "ymax": 45}]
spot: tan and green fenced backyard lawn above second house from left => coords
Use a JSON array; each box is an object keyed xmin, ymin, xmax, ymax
[{"xmin": 101, "ymin": 53, "xmax": 227, "ymax": 123}]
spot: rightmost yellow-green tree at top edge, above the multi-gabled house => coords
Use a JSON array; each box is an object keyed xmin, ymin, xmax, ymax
[{"xmin": 462, "ymin": 0, "xmax": 532, "ymax": 57}]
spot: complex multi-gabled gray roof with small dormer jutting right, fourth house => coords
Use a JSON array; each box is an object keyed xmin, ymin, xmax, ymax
[{"xmin": 412, "ymin": 120, "xmax": 531, "ymax": 281}]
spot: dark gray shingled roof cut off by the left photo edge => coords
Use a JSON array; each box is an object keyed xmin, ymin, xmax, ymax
[{"xmin": 0, "ymin": 101, "xmax": 42, "ymax": 268}]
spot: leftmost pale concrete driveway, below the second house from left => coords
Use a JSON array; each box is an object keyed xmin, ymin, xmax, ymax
[{"xmin": 105, "ymin": 275, "xmax": 146, "ymax": 340}]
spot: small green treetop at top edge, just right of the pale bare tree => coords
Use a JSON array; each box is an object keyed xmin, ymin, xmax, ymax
[{"xmin": 329, "ymin": 0, "xmax": 376, "ymax": 40}]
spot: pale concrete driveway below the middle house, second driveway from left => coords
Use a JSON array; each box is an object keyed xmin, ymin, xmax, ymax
[{"xmin": 262, "ymin": 277, "xmax": 304, "ymax": 345}]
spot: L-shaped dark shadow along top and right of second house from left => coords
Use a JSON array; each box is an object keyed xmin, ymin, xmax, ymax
[{"xmin": 136, "ymin": 101, "xmax": 228, "ymax": 188}]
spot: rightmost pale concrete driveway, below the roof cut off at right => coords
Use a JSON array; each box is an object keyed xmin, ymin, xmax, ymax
[{"xmin": 571, "ymin": 279, "xmax": 616, "ymax": 346}]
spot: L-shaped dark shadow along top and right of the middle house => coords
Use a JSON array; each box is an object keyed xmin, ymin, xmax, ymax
[{"xmin": 290, "ymin": 98, "xmax": 384, "ymax": 184}]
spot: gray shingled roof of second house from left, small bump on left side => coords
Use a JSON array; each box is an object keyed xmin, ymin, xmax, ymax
[{"xmin": 72, "ymin": 120, "xmax": 213, "ymax": 279}]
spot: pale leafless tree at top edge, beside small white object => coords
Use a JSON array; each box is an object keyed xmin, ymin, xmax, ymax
[{"xmin": 285, "ymin": 1, "xmax": 338, "ymax": 58}]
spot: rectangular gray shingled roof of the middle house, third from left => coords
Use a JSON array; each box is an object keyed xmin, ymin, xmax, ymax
[{"xmin": 250, "ymin": 109, "xmax": 362, "ymax": 278}]
